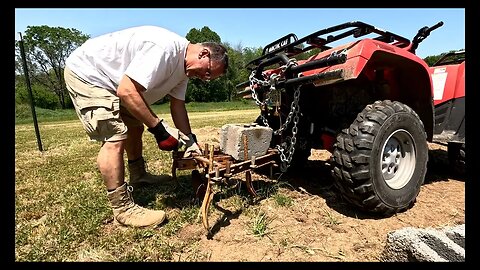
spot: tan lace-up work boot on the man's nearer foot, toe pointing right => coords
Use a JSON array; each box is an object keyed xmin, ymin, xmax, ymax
[{"xmin": 107, "ymin": 183, "xmax": 165, "ymax": 227}]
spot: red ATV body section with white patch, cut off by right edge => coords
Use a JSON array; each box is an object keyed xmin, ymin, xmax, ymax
[{"xmin": 430, "ymin": 50, "xmax": 465, "ymax": 174}]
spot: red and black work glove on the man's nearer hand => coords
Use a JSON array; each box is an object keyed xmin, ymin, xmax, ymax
[{"xmin": 148, "ymin": 119, "xmax": 189, "ymax": 151}]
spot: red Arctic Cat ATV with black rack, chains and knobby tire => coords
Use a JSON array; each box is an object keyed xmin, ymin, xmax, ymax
[{"xmin": 238, "ymin": 21, "xmax": 456, "ymax": 215}]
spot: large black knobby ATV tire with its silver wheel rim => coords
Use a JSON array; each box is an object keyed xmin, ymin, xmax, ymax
[{"xmin": 332, "ymin": 100, "xmax": 428, "ymax": 216}]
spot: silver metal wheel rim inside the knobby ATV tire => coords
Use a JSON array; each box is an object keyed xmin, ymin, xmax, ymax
[{"xmin": 380, "ymin": 129, "xmax": 416, "ymax": 189}]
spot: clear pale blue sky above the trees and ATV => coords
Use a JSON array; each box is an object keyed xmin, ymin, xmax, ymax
[{"xmin": 15, "ymin": 8, "xmax": 465, "ymax": 58}]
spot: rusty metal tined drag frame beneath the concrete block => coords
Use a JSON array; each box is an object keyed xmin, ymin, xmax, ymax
[{"xmin": 172, "ymin": 142, "xmax": 279, "ymax": 232}]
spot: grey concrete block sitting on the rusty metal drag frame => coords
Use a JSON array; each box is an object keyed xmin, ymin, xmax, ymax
[{"xmin": 220, "ymin": 123, "xmax": 273, "ymax": 161}]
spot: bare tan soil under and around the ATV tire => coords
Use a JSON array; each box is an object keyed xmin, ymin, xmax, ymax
[{"xmin": 172, "ymin": 127, "xmax": 465, "ymax": 262}]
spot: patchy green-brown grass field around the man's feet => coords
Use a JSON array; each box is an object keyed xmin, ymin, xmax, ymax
[{"xmin": 15, "ymin": 102, "xmax": 289, "ymax": 262}]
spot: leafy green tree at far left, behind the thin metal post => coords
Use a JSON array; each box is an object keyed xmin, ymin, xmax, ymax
[{"xmin": 15, "ymin": 25, "xmax": 90, "ymax": 109}]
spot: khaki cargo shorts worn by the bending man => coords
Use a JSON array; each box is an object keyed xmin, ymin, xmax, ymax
[{"xmin": 64, "ymin": 67, "xmax": 143, "ymax": 142}]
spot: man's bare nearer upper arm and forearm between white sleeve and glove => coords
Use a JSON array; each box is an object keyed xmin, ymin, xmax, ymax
[{"xmin": 117, "ymin": 75, "xmax": 160, "ymax": 128}]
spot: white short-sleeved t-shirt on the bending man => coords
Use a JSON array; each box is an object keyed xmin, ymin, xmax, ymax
[{"xmin": 65, "ymin": 26, "xmax": 189, "ymax": 104}]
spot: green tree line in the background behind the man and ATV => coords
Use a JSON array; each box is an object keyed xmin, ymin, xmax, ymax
[{"xmin": 15, "ymin": 25, "xmax": 462, "ymax": 110}]
